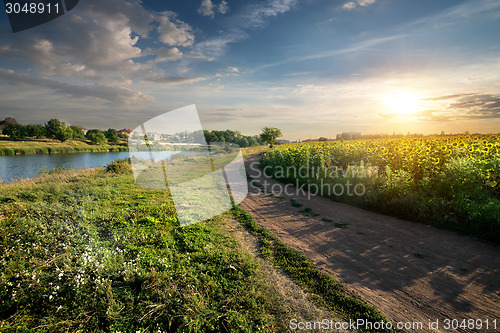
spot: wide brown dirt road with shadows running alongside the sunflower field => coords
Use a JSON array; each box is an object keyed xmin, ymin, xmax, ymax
[{"xmin": 242, "ymin": 156, "xmax": 500, "ymax": 332}]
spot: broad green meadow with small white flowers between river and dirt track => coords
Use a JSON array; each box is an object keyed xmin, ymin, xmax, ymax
[{"xmin": 0, "ymin": 161, "xmax": 286, "ymax": 332}]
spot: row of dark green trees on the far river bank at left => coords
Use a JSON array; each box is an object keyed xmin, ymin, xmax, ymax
[{"xmin": 2, "ymin": 119, "xmax": 127, "ymax": 145}]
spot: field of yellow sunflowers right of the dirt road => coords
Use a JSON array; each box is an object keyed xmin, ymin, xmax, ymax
[{"xmin": 261, "ymin": 135, "xmax": 500, "ymax": 242}]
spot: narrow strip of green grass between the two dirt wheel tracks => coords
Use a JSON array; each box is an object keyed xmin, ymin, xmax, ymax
[{"xmin": 233, "ymin": 207, "xmax": 391, "ymax": 332}]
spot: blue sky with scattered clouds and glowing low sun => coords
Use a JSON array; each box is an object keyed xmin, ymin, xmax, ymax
[{"xmin": 0, "ymin": 0, "xmax": 500, "ymax": 140}]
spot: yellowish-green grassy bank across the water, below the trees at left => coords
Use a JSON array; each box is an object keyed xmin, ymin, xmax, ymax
[{"xmin": 0, "ymin": 136, "xmax": 128, "ymax": 155}]
